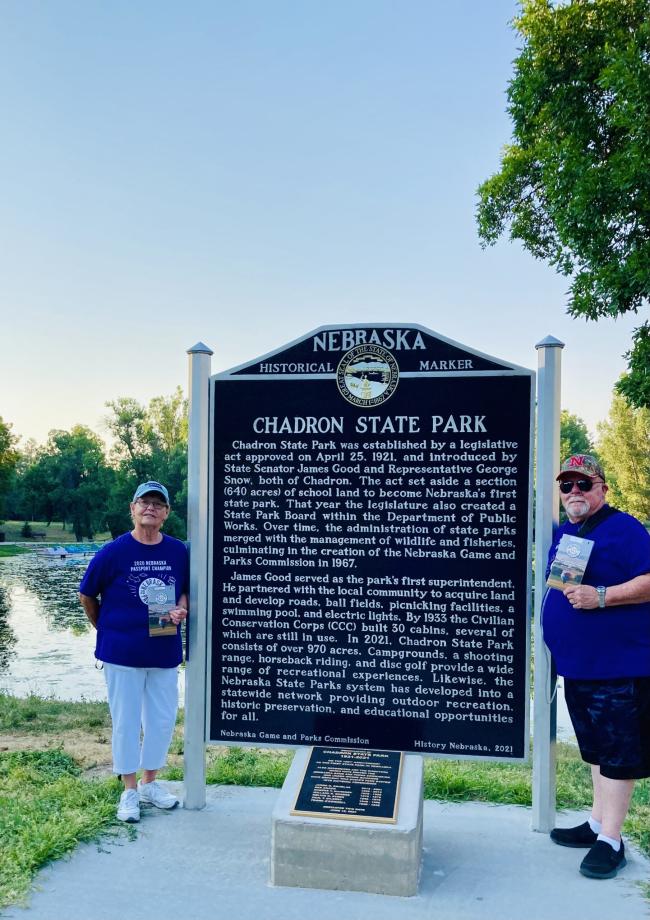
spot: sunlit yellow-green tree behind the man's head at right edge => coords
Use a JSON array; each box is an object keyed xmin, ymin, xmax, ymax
[{"xmin": 598, "ymin": 392, "xmax": 650, "ymax": 521}]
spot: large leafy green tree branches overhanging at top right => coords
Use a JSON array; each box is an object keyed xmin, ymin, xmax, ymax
[{"xmin": 477, "ymin": 0, "xmax": 650, "ymax": 408}]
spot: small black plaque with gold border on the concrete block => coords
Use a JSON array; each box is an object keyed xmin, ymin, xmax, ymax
[{"xmin": 291, "ymin": 747, "xmax": 403, "ymax": 824}]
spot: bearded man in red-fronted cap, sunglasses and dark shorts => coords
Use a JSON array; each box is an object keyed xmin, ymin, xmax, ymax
[{"xmin": 543, "ymin": 454, "xmax": 650, "ymax": 879}]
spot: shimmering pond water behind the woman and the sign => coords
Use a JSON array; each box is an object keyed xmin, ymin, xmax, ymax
[{"xmin": 0, "ymin": 553, "xmax": 574, "ymax": 740}]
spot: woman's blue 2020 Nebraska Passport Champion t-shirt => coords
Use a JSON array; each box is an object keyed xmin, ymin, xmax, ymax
[{"xmin": 79, "ymin": 533, "xmax": 189, "ymax": 668}]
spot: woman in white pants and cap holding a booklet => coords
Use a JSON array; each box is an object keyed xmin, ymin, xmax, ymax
[{"xmin": 79, "ymin": 481, "xmax": 189, "ymax": 823}]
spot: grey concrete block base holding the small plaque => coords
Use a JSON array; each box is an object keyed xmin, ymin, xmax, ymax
[{"xmin": 271, "ymin": 748, "xmax": 423, "ymax": 897}]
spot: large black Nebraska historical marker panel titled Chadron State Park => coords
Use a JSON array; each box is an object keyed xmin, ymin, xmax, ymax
[{"xmin": 209, "ymin": 326, "xmax": 533, "ymax": 758}]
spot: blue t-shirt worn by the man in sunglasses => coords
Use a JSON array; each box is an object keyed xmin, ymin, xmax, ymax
[{"xmin": 542, "ymin": 511, "xmax": 650, "ymax": 680}]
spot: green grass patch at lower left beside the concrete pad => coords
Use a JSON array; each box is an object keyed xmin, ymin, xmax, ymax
[{"xmin": 0, "ymin": 751, "xmax": 120, "ymax": 908}]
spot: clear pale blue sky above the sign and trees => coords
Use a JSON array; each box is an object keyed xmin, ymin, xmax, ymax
[{"xmin": 0, "ymin": 0, "xmax": 640, "ymax": 444}]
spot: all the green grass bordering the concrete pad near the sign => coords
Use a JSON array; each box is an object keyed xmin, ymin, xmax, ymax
[{"xmin": 0, "ymin": 693, "xmax": 650, "ymax": 908}]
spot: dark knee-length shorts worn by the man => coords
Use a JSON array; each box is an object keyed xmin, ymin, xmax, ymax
[{"xmin": 564, "ymin": 677, "xmax": 650, "ymax": 779}]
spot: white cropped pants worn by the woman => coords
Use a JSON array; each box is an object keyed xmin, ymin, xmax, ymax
[{"xmin": 104, "ymin": 662, "xmax": 178, "ymax": 775}]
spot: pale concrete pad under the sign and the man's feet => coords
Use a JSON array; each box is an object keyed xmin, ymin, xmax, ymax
[{"xmin": 3, "ymin": 783, "xmax": 650, "ymax": 920}]
